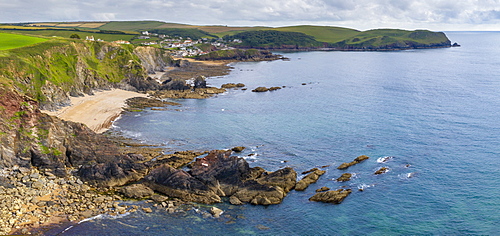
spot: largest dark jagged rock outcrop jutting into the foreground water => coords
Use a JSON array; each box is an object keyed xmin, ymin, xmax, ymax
[{"xmin": 144, "ymin": 151, "xmax": 297, "ymax": 205}]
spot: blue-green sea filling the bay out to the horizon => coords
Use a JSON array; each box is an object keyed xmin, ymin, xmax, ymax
[{"xmin": 61, "ymin": 32, "xmax": 500, "ymax": 235}]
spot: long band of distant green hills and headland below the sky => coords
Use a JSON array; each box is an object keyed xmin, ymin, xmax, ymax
[{"xmin": 0, "ymin": 21, "xmax": 451, "ymax": 50}]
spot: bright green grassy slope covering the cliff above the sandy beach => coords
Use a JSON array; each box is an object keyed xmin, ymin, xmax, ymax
[{"xmin": 0, "ymin": 38, "xmax": 143, "ymax": 101}]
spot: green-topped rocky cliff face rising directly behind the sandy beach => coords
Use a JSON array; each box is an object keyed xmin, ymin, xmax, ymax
[{"xmin": 0, "ymin": 41, "xmax": 172, "ymax": 110}]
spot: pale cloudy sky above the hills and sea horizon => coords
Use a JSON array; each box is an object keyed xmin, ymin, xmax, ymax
[{"xmin": 0, "ymin": 0, "xmax": 500, "ymax": 31}]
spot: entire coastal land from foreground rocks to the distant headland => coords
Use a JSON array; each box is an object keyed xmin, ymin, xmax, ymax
[{"xmin": 0, "ymin": 21, "xmax": 458, "ymax": 234}]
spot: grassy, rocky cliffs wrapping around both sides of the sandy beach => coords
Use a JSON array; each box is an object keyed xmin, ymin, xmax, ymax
[{"xmin": 0, "ymin": 41, "xmax": 171, "ymax": 186}]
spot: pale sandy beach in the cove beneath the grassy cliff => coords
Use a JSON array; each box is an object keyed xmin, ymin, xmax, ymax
[{"xmin": 42, "ymin": 89, "xmax": 147, "ymax": 133}]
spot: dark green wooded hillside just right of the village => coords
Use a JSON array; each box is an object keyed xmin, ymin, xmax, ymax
[{"xmin": 224, "ymin": 30, "xmax": 323, "ymax": 49}]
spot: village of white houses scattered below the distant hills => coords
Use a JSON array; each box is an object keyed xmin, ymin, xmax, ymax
[{"xmin": 85, "ymin": 31, "xmax": 242, "ymax": 57}]
